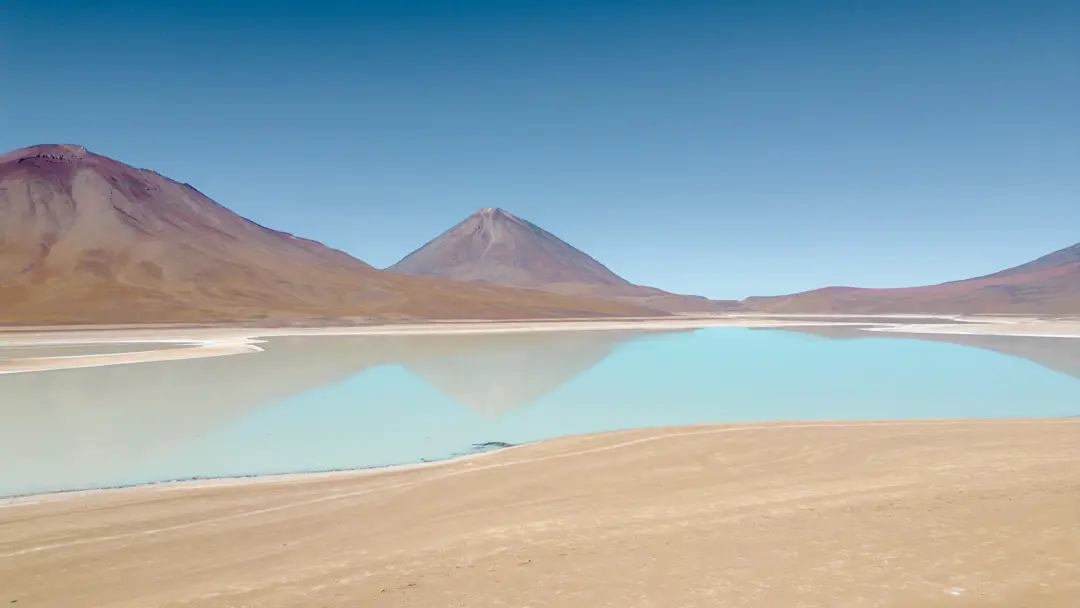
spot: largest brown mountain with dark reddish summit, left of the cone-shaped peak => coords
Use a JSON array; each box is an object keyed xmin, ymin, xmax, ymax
[{"xmin": 0, "ymin": 145, "xmax": 657, "ymax": 323}]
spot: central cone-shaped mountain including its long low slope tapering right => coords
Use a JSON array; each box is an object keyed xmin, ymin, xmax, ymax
[{"xmin": 387, "ymin": 208, "xmax": 738, "ymax": 312}]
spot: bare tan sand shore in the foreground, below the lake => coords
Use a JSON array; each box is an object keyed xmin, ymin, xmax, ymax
[{"xmin": 0, "ymin": 420, "xmax": 1080, "ymax": 608}]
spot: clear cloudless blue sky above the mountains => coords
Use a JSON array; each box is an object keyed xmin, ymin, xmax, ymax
[{"xmin": 0, "ymin": 0, "xmax": 1080, "ymax": 298}]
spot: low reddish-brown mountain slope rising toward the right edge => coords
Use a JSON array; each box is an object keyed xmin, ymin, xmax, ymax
[{"xmin": 743, "ymin": 244, "xmax": 1080, "ymax": 314}]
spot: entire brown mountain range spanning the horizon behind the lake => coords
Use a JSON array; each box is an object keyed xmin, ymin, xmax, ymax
[{"xmin": 8, "ymin": 144, "xmax": 1080, "ymax": 323}]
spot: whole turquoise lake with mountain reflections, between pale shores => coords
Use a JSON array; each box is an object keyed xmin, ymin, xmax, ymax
[{"xmin": 0, "ymin": 327, "xmax": 1080, "ymax": 496}]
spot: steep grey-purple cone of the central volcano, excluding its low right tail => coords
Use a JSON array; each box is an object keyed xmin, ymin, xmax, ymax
[{"xmin": 389, "ymin": 207, "xmax": 630, "ymax": 288}]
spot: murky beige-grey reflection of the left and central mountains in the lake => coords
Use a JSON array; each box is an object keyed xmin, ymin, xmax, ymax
[{"xmin": 0, "ymin": 332, "xmax": 678, "ymax": 496}]
